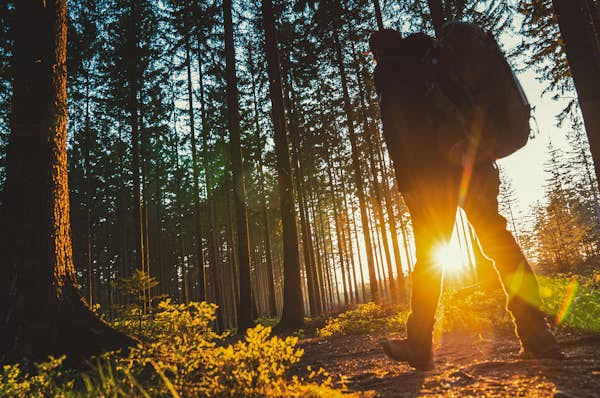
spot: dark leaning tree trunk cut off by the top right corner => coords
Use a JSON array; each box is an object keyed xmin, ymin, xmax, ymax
[{"xmin": 552, "ymin": 0, "xmax": 600, "ymax": 187}]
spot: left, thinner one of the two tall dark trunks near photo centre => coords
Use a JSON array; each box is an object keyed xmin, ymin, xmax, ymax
[{"xmin": 223, "ymin": 0, "xmax": 252, "ymax": 331}]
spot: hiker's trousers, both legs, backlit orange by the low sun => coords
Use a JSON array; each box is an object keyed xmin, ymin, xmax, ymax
[{"xmin": 403, "ymin": 161, "xmax": 547, "ymax": 351}]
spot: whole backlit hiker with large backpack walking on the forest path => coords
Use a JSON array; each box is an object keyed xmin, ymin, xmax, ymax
[{"xmin": 369, "ymin": 23, "xmax": 563, "ymax": 370}]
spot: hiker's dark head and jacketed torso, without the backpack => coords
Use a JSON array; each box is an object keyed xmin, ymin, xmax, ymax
[{"xmin": 372, "ymin": 33, "xmax": 471, "ymax": 170}]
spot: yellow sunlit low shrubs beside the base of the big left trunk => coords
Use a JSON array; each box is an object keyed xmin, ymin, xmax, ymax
[{"xmin": 0, "ymin": 300, "xmax": 343, "ymax": 398}]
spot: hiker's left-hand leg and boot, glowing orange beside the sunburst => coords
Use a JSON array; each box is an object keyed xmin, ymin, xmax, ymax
[{"xmin": 383, "ymin": 182, "xmax": 456, "ymax": 370}]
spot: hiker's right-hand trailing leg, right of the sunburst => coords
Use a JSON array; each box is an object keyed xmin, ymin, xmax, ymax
[{"xmin": 463, "ymin": 163, "xmax": 561, "ymax": 357}]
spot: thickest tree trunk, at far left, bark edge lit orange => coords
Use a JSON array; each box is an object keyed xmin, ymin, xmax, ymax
[{"xmin": 0, "ymin": 0, "xmax": 135, "ymax": 361}]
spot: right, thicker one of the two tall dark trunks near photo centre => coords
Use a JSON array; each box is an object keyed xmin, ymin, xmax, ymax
[{"xmin": 262, "ymin": 0, "xmax": 304, "ymax": 328}]
